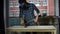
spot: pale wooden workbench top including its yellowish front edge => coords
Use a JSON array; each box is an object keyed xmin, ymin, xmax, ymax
[{"xmin": 7, "ymin": 26, "xmax": 56, "ymax": 32}]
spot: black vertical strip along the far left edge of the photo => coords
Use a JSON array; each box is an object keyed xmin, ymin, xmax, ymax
[{"xmin": 0, "ymin": 0, "xmax": 5, "ymax": 34}]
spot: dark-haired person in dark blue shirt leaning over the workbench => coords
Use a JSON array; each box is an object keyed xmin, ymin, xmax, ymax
[{"xmin": 19, "ymin": 0, "xmax": 40, "ymax": 27}]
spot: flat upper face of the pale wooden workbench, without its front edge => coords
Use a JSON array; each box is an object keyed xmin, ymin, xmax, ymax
[{"xmin": 7, "ymin": 26, "xmax": 55, "ymax": 29}]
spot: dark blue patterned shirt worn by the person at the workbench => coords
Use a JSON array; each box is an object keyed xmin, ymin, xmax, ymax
[{"xmin": 19, "ymin": 3, "xmax": 39, "ymax": 24}]
